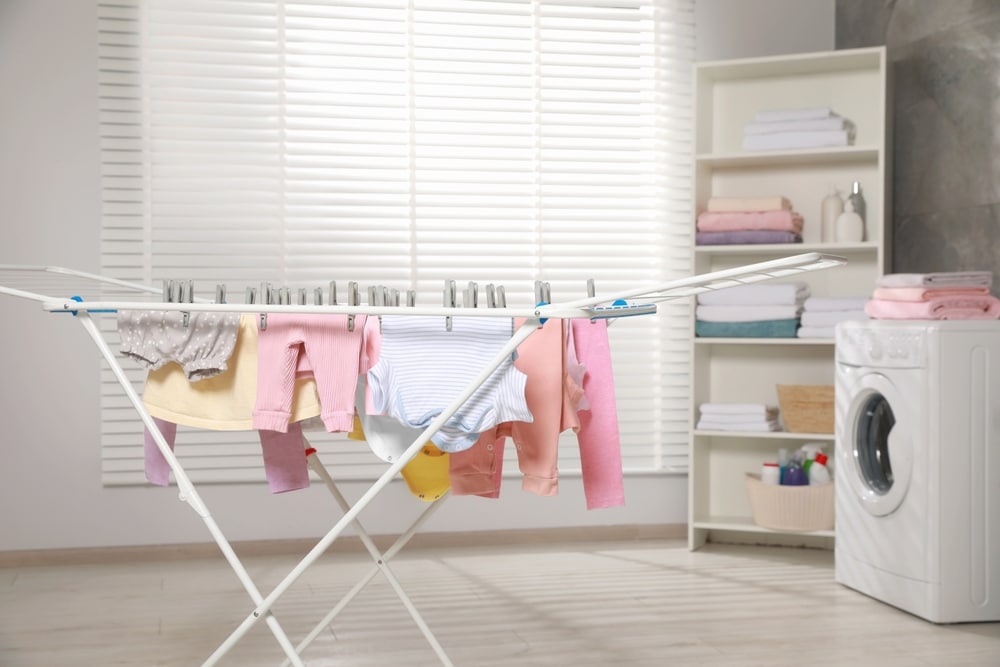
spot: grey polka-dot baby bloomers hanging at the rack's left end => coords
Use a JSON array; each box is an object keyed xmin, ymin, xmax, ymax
[{"xmin": 118, "ymin": 310, "xmax": 240, "ymax": 382}]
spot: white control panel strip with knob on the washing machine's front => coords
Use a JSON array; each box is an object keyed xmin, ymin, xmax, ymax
[{"xmin": 837, "ymin": 322, "xmax": 927, "ymax": 368}]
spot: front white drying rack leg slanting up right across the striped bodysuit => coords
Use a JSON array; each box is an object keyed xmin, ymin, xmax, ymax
[{"xmin": 210, "ymin": 318, "xmax": 542, "ymax": 667}]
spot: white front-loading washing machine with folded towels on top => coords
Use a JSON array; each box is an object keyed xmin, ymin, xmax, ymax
[{"xmin": 834, "ymin": 320, "xmax": 1000, "ymax": 623}]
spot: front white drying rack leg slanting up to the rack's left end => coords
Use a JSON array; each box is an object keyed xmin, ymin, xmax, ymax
[{"xmin": 77, "ymin": 311, "xmax": 304, "ymax": 667}]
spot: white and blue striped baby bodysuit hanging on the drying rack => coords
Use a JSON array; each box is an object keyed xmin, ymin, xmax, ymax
[{"xmin": 367, "ymin": 315, "xmax": 532, "ymax": 453}]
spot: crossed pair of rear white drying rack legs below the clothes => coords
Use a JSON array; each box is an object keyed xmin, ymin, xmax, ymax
[{"xmin": 282, "ymin": 451, "xmax": 452, "ymax": 667}]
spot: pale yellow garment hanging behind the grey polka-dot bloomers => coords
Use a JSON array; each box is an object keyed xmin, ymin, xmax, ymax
[{"xmin": 142, "ymin": 313, "xmax": 320, "ymax": 431}]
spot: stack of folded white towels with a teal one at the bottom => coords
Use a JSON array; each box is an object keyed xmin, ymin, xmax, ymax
[{"xmin": 695, "ymin": 282, "xmax": 810, "ymax": 338}]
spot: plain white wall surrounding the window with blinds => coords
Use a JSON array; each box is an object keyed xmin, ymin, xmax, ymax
[{"xmin": 0, "ymin": 0, "xmax": 833, "ymax": 551}]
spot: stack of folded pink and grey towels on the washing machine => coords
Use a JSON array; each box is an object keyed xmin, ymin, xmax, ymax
[{"xmin": 865, "ymin": 271, "xmax": 1000, "ymax": 320}]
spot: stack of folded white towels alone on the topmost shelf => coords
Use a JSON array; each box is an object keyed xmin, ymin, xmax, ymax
[{"xmin": 743, "ymin": 107, "xmax": 855, "ymax": 151}]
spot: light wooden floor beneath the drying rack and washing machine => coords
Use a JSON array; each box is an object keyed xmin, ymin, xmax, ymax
[{"xmin": 0, "ymin": 539, "xmax": 1000, "ymax": 667}]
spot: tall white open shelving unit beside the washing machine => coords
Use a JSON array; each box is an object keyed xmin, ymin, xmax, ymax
[{"xmin": 688, "ymin": 47, "xmax": 892, "ymax": 549}]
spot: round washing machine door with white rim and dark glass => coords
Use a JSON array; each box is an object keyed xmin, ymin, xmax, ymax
[{"xmin": 838, "ymin": 372, "xmax": 919, "ymax": 516}]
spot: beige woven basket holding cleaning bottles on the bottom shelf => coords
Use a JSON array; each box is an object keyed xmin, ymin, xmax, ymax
[{"xmin": 746, "ymin": 473, "xmax": 833, "ymax": 532}]
